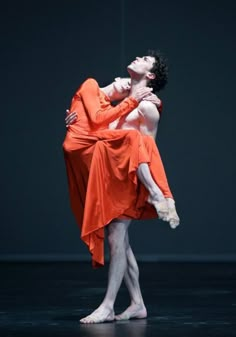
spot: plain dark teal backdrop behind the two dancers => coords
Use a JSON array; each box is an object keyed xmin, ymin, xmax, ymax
[{"xmin": 0, "ymin": 0, "xmax": 236, "ymax": 260}]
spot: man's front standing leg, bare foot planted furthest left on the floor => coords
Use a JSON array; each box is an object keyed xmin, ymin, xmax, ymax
[{"xmin": 80, "ymin": 219, "xmax": 131, "ymax": 323}]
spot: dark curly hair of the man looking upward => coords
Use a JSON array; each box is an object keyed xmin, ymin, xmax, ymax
[{"xmin": 147, "ymin": 50, "xmax": 168, "ymax": 92}]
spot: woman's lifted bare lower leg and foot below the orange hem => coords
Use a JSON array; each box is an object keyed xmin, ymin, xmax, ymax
[{"xmin": 137, "ymin": 163, "xmax": 169, "ymax": 221}]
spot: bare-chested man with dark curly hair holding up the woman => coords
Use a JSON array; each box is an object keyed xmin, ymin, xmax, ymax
[{"xmin": 63, "ymin": 50, "xmax": 179, "ymax": 323}]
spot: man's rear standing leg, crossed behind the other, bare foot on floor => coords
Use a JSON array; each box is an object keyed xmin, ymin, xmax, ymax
[{"xmin": 115, "ymin": 231, "xmax": 147, "ymax": 320}]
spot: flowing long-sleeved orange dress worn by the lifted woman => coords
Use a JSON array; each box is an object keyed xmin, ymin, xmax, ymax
[{"xmin": 63, "ymin": 79, "xmax": 172, "ymax": 267}]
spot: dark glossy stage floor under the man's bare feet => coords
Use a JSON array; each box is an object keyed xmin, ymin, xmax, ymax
[{"xmin": 0, "ymin": 262, "xmax": 236, "ymax": 337}]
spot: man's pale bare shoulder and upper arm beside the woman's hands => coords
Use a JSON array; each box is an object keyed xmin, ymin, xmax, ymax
[{"xmin": 138, "ymin": 101, "xmax": 160, "ymax": 139}]
